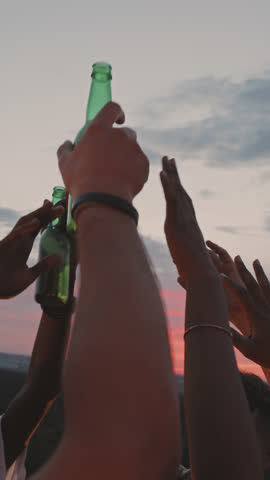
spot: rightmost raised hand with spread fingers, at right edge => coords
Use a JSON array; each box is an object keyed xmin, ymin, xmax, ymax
[{"xmin": 224, "ymin": 256, "xmax": 270, "ymax": 369}]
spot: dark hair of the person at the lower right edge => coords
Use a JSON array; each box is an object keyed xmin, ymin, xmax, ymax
[{"xmin": 240, "ymin": 372, "xmax": 270, "ymax": 417}]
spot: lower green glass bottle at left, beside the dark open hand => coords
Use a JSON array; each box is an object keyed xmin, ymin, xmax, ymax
[{"xmin": 35, "ymin": 187, "xmax": 70, "ymax": 308}]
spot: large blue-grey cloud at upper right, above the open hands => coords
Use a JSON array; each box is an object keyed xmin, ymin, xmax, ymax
[{"xmin": 139, "ymin": 72, "xmax": 270, "ymax": 167}]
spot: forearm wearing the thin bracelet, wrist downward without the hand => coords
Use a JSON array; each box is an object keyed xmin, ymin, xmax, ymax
[{"xmin": 185, "ymin": 269, "xmax": 263, "ymax": 480}]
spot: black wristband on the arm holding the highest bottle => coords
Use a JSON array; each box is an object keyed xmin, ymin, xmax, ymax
[{"xmin": 72, "ymin": 192, "xmax": 139, "ymax": 225}]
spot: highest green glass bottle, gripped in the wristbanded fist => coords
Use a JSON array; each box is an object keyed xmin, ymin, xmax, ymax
[{"xmin": 67, "ymin": 62, "xmax": 112, "ymax": 234}]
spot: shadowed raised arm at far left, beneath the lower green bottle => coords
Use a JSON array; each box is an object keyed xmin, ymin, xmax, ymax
[{"xmin": 1, "ymin": 224, "xmax": 77, "ymax": 469}]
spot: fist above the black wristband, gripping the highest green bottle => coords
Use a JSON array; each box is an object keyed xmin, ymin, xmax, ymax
[{"xmin": 57, "ymin": 102, "xmax": 149, "ymax": 202}]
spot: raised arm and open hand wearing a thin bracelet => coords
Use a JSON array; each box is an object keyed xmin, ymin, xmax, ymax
[{"xmin": 161, "ymin": 158, "xmax": 263, "ymax": 480}]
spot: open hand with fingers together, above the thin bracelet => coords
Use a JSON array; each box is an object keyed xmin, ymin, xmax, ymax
[{"xmin": 160, "ymin": 157, "xmax": 211, "ymax": 284}]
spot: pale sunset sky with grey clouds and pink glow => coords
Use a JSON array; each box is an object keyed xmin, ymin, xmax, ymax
[{"xmin": 0, "ymin": 0, "xmax": 270, "ymax": 378}]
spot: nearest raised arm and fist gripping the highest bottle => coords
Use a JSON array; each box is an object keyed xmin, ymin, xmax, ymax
[{"xmin": 32, "ymin": 103, "xmax": 180, "ymax": 480}]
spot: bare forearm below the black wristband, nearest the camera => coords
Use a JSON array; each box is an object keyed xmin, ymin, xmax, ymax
[{"xmin": 64, "ymin": 208, "xmax": 180, "ymax": 478}]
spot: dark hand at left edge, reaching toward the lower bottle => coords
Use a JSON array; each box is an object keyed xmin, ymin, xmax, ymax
[{"xmin": 0, "ymin": 200, "xmax": 64, "ymax": 298}]
